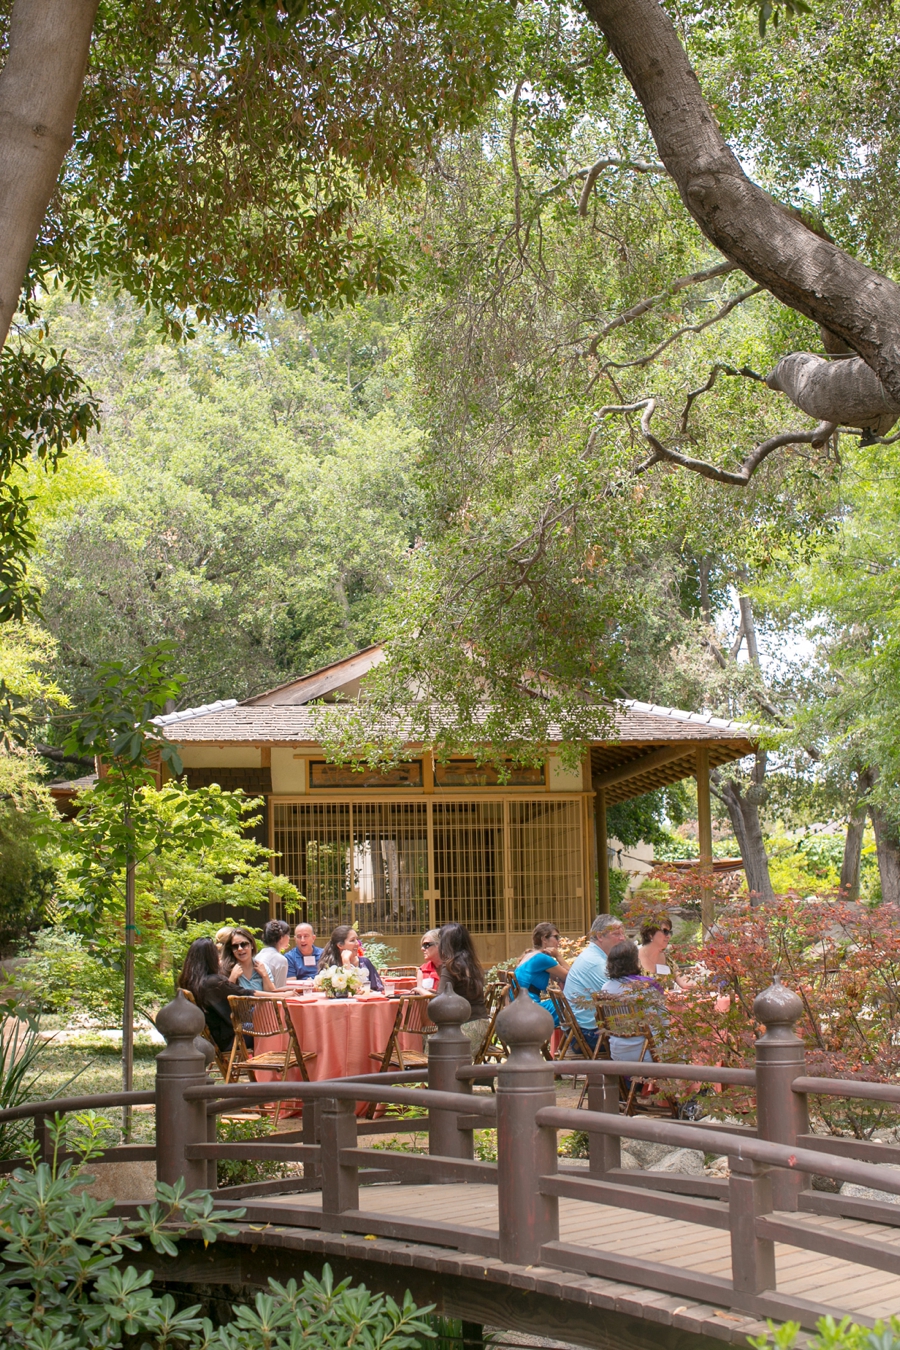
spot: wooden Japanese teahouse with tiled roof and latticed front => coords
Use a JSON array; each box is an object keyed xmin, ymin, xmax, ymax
[{"xmin": 159, "ymin": 647, "xmax": 754, "ymax": 963}]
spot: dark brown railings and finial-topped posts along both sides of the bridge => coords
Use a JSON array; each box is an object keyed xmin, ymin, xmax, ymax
[{"xmin": 0, "ymin": 980, "xmax": 900, "ymax": 1323}]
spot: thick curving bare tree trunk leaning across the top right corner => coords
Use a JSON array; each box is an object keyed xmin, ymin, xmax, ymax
[{"xmin": 584, "ymin": 0, "xmax": 900, "ymax": 400}]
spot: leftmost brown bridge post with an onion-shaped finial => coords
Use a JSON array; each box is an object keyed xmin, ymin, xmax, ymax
[{"xmin": 157, "ymin": 990, "xmax": 208, "ymax": 1192}]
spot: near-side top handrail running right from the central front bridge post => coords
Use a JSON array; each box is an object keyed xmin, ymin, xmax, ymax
[{"xmin": 536, "ymin": 1106, "xmax": 900, "ymax": 1195}]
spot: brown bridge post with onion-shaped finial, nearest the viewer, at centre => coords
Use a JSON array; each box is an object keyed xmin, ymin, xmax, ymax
[{"xmin": 497, "ymin": 994, "xmax": 560, "ymax": 1265}]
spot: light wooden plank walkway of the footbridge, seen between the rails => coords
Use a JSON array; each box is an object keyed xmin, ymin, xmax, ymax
[{"xmin": 255, "ymin": 1184, "xmax": 900, "ymax": 1318}]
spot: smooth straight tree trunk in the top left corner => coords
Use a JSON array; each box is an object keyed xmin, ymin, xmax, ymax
[{"xmin": 0, "ymin": 0, "xmax": 97, "ymax": 346}]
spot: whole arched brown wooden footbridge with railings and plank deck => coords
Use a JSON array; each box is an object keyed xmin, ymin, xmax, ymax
[{"xmin": 8, "ymin": 980, "xmax": 900, "ymax": 1350}]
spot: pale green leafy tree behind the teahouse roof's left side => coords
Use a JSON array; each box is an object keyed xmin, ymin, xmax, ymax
[{"xmin": 28, "ymin": 294, "xmax": 421, "ymax": 706}]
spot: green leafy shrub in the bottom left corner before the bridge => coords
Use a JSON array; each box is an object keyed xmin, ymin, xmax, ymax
[{"xmin": 0, "ymin": 1112, "xmax": 434, "ymax": 1350}]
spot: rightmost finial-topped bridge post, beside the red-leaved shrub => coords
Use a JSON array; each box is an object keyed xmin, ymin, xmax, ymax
[{"xmin": 753, "ymin": 975, "xmax": 810, "ymax": 1210}]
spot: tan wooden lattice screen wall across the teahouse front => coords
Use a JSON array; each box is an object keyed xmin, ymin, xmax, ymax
[{"xmin": 273, "ymin": 795, "xmax": 583, "ymax": 937}]
